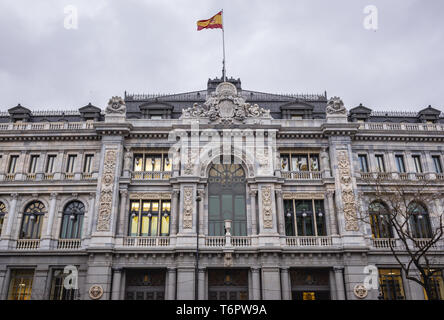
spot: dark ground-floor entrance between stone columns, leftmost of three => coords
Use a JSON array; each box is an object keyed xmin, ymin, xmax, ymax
[{"xmin": 125, "ymin": 269, "xmax": 166, "ymax": 300}]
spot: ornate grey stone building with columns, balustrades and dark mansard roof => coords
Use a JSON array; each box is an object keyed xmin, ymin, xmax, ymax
[{"xmin": 0, "ymin": 78, "xmax": 444, "ymax": 300}]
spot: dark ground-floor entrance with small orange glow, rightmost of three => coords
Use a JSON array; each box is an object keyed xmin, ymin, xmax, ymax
[{"xmin": 290, "ymin": 269, "xmax": 331, "ymax": 300}]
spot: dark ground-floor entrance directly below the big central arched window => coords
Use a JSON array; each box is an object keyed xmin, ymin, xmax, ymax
[{"xmin": 208, "ymin": 269, "xmax": 248, "ymax": 300}]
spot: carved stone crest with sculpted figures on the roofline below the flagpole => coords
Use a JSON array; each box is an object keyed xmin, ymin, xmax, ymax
[{"xmin": 181, "ymin": 82, "xmax": 271, "ymax": 124}]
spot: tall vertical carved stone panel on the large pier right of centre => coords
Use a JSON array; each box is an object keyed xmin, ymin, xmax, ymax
[{"xmin": 338, "ymin": 150, "xmax": 359, "ymax": 231}]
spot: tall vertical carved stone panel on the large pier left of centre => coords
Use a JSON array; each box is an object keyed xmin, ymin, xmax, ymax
[{"xmin": 97, "ymin": 149, "xmax": 117, "ymax": 231}]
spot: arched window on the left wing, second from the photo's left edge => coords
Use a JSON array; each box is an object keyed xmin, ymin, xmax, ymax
[{"xmin": 60, "ymin": 201, "xmax": 85, "ymax": 239}]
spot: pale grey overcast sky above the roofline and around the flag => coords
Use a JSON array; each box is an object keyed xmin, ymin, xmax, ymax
[{"xmin": 0, "ymin": 0, "xmax": 444, "ymax": 111}]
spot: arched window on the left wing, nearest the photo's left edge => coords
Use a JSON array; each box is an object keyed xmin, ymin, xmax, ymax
[{"xmin": 20, "ymin": 201, "xmax": 46, "ymax": 239}]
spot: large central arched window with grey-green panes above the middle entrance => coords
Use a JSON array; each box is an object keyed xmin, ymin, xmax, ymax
[{"xmin": 208, "ymin": 159, "xmax": 247, "ymax": 236}]
